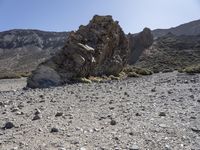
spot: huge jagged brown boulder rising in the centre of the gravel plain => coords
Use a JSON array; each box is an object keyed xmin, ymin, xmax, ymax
[{"xmin": 27, "ymin": 15, "xmax": 129, "ymax": 88}]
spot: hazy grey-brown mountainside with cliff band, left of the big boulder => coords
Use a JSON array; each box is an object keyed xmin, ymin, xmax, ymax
[{"xmin": 0, "ymin": 30, "xmax": 68, "ymax": 77}]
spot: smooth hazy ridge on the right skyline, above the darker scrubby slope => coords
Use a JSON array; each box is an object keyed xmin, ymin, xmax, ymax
[{"xmin": 152, "ymin": 20, "xmax": 200, "ymax": 37}]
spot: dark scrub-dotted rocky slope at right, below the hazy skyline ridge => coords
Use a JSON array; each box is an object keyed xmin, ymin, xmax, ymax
[{"xmin": 135, "ymin": 34, "xmax": 200, "ymax": 72}]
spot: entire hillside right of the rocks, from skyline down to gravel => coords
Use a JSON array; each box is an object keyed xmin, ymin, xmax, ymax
[{"xmin": 135, "ymin": 20, "xmax": 200, "ymax": 72}]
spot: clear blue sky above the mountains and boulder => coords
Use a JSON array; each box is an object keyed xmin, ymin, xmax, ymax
[{"xmin": 0, "ymin": 0, "xmax": 200, "ymax": 33}]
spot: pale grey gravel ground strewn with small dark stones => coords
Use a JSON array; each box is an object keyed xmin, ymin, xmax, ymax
[{"xmin": 0, "ymin": 72, "xmax": 200, "ymax": 150}]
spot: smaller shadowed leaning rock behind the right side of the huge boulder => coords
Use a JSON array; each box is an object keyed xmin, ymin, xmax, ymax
[{"xmin": 128, "ymin": 28, "xmax": 153, "ymax": 65}]
